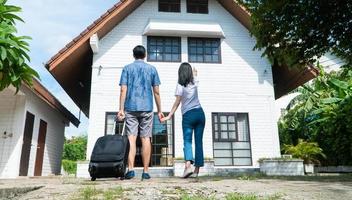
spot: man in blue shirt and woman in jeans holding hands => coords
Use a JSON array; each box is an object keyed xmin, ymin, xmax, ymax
[{"xmin": 117, "ymin": 45, "xmax": 205, "ymax": 179}]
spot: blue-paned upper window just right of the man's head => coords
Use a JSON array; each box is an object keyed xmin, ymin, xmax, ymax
[{"xmin": 148, "ymin": 37, "xmax": 181, "ymax": 62}]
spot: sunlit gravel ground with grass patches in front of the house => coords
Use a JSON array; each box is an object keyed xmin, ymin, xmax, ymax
[{"xmin": 0, "ymin": 175, "xmax": 352, "ymax": 200}]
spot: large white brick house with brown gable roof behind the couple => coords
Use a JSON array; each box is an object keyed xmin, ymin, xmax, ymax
[{"xmin": 46, "ymin": 0, "xmax": 317, "ymax": 175}]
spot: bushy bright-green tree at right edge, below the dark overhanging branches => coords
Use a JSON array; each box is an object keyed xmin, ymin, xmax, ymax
[{"xmin": 279, "ymin": 68, "xmax": 352, "ymax": 165}]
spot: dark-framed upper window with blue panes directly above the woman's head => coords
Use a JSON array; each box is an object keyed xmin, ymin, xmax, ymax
[{"xmin": 188, "ymin": 38, "xmax": 221, "ymax": 63}]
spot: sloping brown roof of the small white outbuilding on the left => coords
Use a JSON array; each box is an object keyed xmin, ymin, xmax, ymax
[{"xmin": 25, "ymin": 79, "xmax": 81, "ymax": 127}]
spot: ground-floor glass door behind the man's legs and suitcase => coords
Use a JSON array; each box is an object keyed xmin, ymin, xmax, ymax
[{"xmin": 105, "ymin": 112, "xmax": 174, "ymax": 167}]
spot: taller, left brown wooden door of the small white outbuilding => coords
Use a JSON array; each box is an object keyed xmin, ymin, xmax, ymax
[{"xmin": 19, "ymin": 112, "xmax": 34, "ymax": 176}]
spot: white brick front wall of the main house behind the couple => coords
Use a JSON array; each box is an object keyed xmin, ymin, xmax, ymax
[{"xmin": 87, "ymin": 0, "xmax": 280, "ymax": 167}]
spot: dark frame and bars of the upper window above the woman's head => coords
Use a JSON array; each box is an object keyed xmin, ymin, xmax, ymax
[{"xmin": 187, "ymin": 37, "xmax": 222, "ymax": 64}]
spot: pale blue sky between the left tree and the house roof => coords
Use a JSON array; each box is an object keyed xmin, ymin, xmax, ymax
[{"xmin": 8, "ymin": 0, "xmax": 118, "ymax": 138}]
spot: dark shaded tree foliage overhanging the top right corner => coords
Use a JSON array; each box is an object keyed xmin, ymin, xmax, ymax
[{"xmin": 238, "ymin": 0, "xmax": 352, "ymax": 67}]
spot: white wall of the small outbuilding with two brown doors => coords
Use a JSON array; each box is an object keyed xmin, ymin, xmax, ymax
[{"xmin": 0, "ymin": 87, "xmax": 65, "ymax": 178}]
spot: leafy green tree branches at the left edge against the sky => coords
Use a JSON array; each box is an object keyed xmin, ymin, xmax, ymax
[{"xmin": 0, "ymin": 0, "xmax": 39, "ymax": 91}]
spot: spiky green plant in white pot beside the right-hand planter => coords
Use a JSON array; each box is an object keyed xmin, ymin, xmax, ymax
[{"xmin": 283, "ymin": 139, "xmax": 326, "ymax": 174}]
